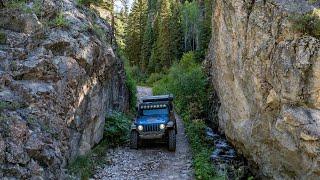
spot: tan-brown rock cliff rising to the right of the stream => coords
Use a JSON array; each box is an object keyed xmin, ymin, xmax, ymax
[{"xmin": 207, "ymin": 0, "xmax": 320, "ymax": 179}]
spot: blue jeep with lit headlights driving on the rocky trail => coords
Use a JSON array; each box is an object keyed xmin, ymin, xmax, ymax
[{"xmin": 131, "ymin": 95, "xmax": 177, "ymax": 151}]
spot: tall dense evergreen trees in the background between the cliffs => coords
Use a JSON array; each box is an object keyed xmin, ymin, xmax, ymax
[{"xmin": 125, "ymin": 0, "xmax": 213, "ymax": 78}]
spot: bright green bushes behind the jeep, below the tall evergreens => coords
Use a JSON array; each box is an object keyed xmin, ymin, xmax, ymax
[{"xmin": 153, "ymin": 52, "xmax": 208, "ymax": 118}]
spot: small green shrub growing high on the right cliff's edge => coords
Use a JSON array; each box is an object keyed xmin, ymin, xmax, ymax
[{"xmin": 290, "ymin": 11, "xmax": 320, "ymax": 39}]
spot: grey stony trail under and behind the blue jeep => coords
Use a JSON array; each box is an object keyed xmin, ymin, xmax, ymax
[{"xmin": 94, "ymin": 87, "xmax": 194, "ymax": 180}]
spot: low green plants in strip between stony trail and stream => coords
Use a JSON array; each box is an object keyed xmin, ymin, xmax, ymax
[{"xmin": 184, "ymin": 119, "xmax": 221, "ymax": 180}]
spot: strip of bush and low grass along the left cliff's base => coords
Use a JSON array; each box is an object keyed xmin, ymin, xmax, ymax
[{"xmin": 67, "ymin": 112, "xmax": 131, "ymax": 180}]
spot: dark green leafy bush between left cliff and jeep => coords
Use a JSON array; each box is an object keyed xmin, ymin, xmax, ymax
[{"xmin": 104, "ymin": 113, "xmax": 131, "ymax": 145}]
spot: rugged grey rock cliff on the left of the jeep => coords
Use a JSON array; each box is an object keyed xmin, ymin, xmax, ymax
[{"xmin": 0, "ymin": 0, "xmax": 128, "ymax": 179}]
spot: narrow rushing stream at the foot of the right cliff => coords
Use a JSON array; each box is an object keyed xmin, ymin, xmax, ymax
[{"xmin": 205, "ymin": 127, "xmax": 252, "ymax": 179}]
